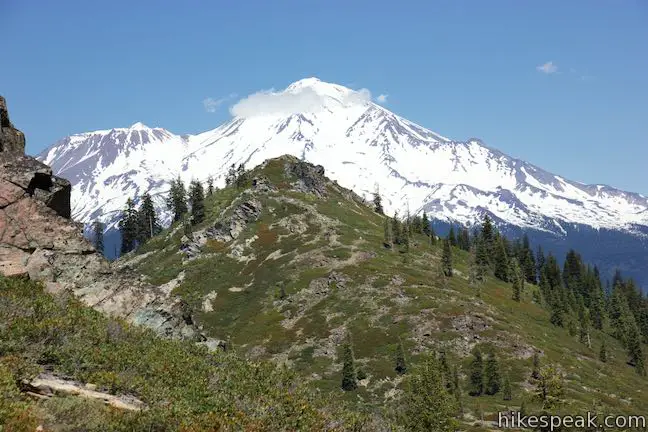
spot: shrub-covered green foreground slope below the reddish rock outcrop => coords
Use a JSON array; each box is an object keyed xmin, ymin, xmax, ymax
[{"xmin": 0, "ymin": 277, "xmax": 371, "ymax": 432}]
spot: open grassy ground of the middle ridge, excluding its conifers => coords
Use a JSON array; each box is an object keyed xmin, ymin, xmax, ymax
[{"xmin": 130, "ymin": 159, "xmax": 648, "ymax": 422}]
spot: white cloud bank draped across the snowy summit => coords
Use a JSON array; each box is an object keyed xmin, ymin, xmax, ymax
[{"xmin": 230, "ymin": 87, "xmax": 371, "ymax": 118}]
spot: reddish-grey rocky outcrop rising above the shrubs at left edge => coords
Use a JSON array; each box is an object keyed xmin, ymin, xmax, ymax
[{"xmin": 0, "ymin": 97, "xmax": 213, "ymax": 345}]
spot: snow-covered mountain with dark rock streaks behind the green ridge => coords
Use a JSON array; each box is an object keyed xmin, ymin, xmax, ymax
[{"xmin": 39, "ymin": 78, "xmax": 648, "ymax": 240}]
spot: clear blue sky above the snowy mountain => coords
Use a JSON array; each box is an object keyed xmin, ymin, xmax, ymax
[{"xmin": 0, "ymin": 0, "xmax": 648, "ymax": 194}]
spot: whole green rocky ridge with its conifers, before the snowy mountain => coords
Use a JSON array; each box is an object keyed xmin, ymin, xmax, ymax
[{"xmin": 111, "ymin": 156, "xmax": 648, "ymax": 422}]
